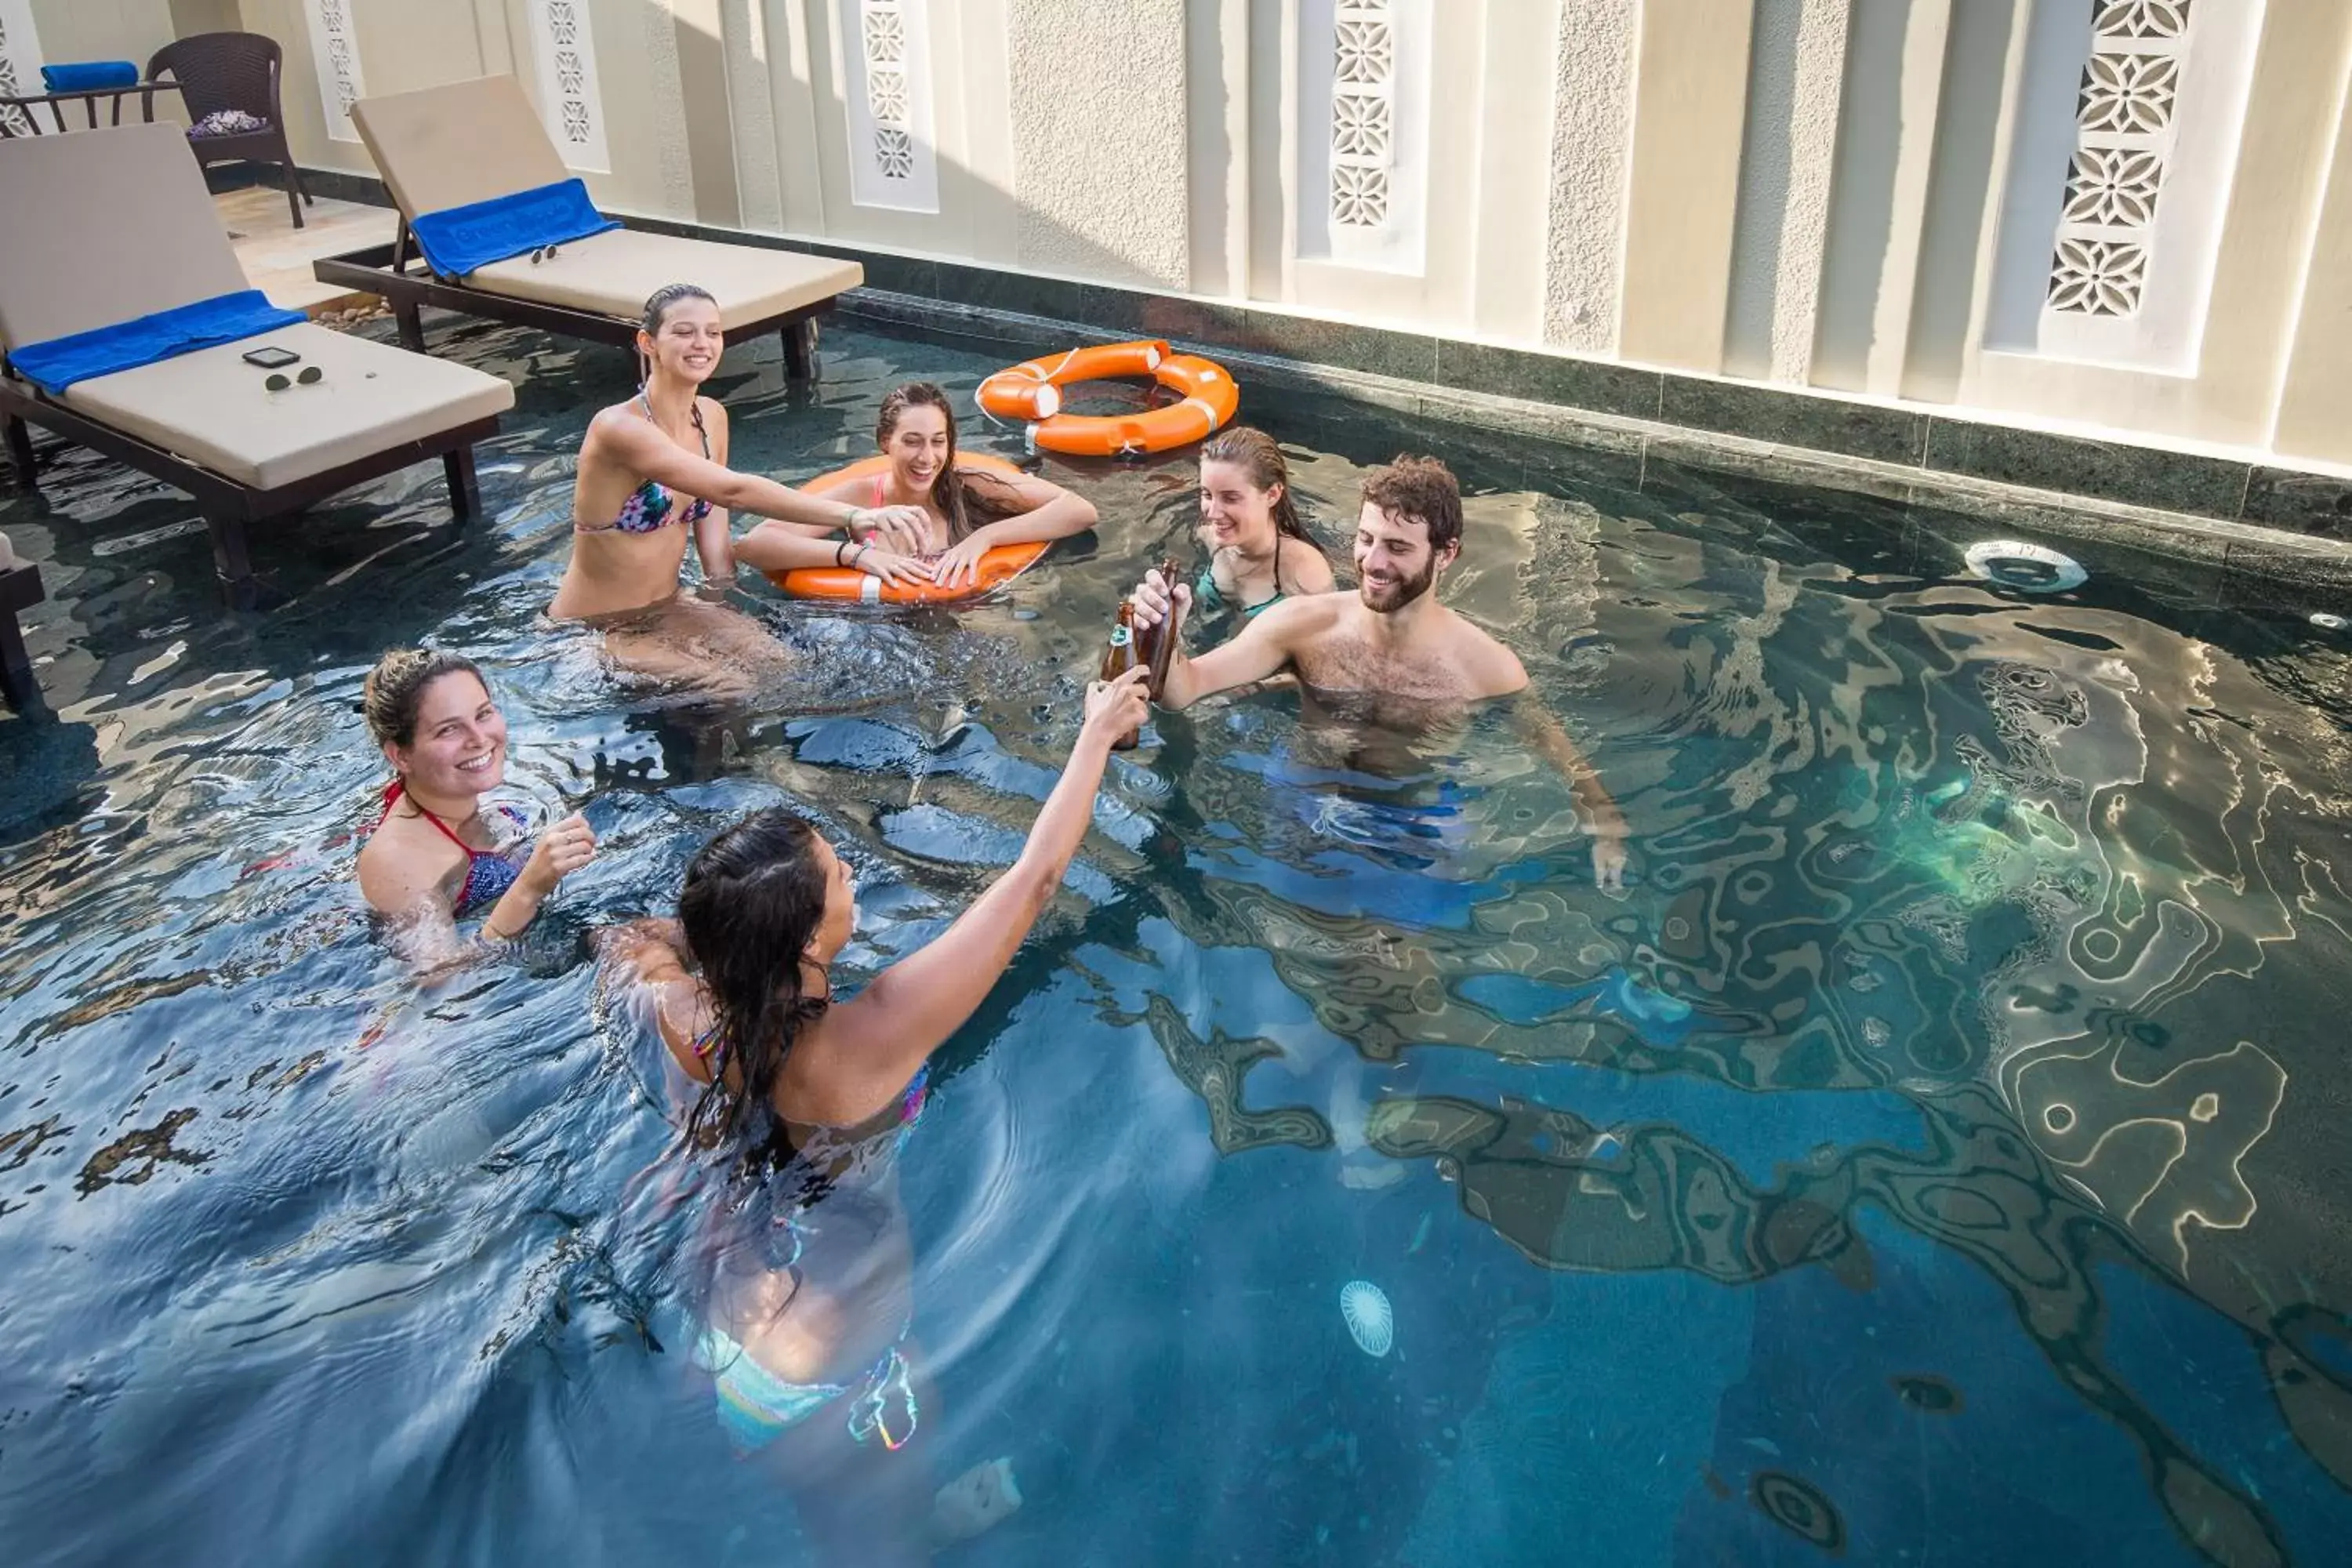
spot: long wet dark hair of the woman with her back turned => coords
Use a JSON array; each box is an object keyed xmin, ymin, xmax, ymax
[{"xmin": 677, "ymin": 806, "xmax": 826, "ymax": 1152}]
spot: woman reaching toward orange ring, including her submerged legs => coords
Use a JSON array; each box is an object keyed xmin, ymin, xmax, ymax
[{"xmin": 548, "ymin": 282, "xmax": 929, "ymax": 684}]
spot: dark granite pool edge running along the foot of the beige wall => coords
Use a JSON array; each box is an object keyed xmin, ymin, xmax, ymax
[{"xmin": 303, "ymin": 169, "xmax": 2352, "ymax": 571}]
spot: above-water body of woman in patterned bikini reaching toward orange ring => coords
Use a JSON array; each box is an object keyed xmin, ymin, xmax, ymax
[{"xmin": 548, "ymin": 285, "xmax": 929, "ymax": 621}]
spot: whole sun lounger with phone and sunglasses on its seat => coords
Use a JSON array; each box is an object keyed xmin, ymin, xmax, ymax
[{"xmin": 0, "ymin": 125, "xmax": 515, "ymax": 604}]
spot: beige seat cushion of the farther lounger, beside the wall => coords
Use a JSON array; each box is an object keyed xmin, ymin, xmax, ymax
[{"xmin": 466, "ymin": 228, "xmax": 866, "ymax": 332}]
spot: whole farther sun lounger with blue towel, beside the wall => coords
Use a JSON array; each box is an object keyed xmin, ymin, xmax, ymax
[{"xmin": 313, "ymin": 75, "xmax": 866, "ymax": 376}]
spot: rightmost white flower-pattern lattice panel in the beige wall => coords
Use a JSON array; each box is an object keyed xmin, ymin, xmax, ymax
[{"xmin": 2046, "ymin": 0, "xmax": 2213, "ymax": 315}]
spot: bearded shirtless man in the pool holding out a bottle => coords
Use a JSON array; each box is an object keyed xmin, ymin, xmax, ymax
[{"xmin": 1134, "ymin": 459, "xmax": 1625, "ymax": 888}]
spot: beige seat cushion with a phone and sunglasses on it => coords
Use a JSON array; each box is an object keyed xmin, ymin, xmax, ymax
[{"xmin": 64, "ymin": 321, "xmax": 515, "ymax": 489}]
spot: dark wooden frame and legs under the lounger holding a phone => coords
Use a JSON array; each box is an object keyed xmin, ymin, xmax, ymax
[{"xmin": 0, "ymin": 360, "xmax": 499, "ymax": 609}]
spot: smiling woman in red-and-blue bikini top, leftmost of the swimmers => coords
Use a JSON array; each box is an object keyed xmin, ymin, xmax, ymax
[{"xmin": 358, "ymin": 649, "xmax": 595, "ymax": 961}]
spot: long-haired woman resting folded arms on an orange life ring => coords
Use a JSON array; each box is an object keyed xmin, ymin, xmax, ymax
[{"xmin": 736, "ymin": 381, "xmax": 1094, "ymax": 588}]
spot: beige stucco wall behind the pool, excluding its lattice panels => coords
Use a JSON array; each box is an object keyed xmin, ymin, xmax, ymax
[{"xmin": 78, "ymin": 0, "xmax": 2352, "ymax": 474}]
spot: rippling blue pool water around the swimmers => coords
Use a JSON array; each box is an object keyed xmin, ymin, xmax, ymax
[{"xmin": 0, "ymin": 322, "xmax": 2352, "ymax": 1568}]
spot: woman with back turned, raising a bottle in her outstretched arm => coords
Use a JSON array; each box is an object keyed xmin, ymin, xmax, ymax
[{"xmin": 607, "ymin": 670, "xmax": 1145, "ymax": 1563}]
